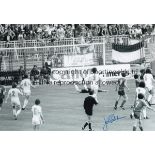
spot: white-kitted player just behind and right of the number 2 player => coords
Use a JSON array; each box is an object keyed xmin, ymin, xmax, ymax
[{"xmin": 20, "ymin": 74, "xmax": 35, "ymax": 110}]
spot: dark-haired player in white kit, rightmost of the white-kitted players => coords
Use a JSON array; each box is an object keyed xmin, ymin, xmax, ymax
[{"xmin": 144, "ymin": 68, "xmax": 155, "ymax": 105}]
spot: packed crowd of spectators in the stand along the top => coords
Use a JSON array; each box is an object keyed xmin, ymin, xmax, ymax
[{"xmin": 0, "ymin": 24, "xmax": 155, "ymax": 42}]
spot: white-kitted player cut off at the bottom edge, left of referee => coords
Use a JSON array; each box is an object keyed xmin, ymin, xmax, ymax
[{"xmin": 32, "ymin": 99, "xmax": 44, "ymax": 131}]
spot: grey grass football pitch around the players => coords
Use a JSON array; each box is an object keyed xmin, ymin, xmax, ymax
[{"xmin": 0, "ymin": 80, "xmax": 155, "ymax": 131}]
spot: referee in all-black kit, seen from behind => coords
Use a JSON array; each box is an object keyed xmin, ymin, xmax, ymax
[{"xmin": 82, "ymin": 90, "xmax": 98, "ymax": 131}]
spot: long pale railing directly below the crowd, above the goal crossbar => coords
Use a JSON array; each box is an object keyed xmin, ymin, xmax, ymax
[{"xmin": 0, "ymin": 35, "xmax": 129, "ymax": 48}]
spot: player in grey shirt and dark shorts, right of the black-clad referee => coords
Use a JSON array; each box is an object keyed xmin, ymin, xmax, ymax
[{"xmin": 114, "ymin": 73, "xmax": 129, "ymax": 110}]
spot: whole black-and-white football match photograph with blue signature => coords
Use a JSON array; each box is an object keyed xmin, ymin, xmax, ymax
[{"xmin": 0, "ymin": 24, "xmax": 155, "ymax": 131}]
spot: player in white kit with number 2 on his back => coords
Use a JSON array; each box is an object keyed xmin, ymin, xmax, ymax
[{"xmin": 5, "ymin": 83, "xmax": 23, "ymax": 120}]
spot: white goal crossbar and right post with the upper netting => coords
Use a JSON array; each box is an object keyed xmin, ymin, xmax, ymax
[{"xmin": 0, "ymin": 42, "xmax": 106, "ymax": 70}]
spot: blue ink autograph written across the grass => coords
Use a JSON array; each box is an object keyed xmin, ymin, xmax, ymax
[{"xmin": 103, "ymin": 114, "xmax": 126, "ymax": 130}]
